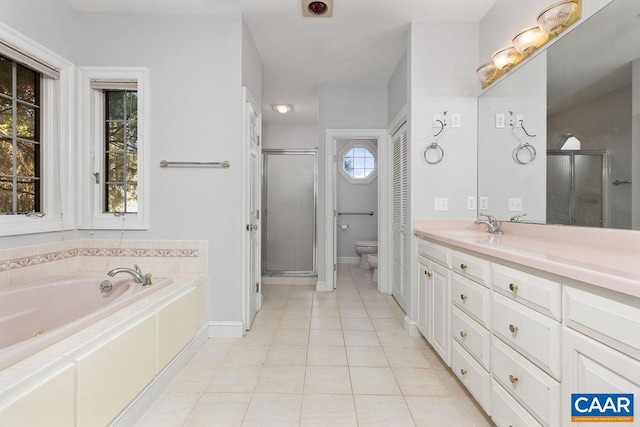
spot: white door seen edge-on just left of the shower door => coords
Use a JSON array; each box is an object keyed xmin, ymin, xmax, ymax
[{"xmin": 244, "ymin": 90, "xmax": 262, "ymax": 329}]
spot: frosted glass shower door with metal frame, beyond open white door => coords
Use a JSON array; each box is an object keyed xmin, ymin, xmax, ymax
[{"xmin": 262, "ymin": 150, "xmax": 317, "ymax": 276}]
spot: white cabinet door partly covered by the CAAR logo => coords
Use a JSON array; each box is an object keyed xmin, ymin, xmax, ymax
[{"xmin": 562, "ymin": 328, "xmax": 640, "ymax": 426}]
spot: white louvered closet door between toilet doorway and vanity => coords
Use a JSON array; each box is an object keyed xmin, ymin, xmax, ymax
[{"xmin": 392, "ymin": 123, "xmax": 411, "ymax": 312}]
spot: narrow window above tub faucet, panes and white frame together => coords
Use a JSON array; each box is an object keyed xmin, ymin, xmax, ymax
[{"xmin": 78, "ymin": 67, "xmax": 149, "ymax": 229}]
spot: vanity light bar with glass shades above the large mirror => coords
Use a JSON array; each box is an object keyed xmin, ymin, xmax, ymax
[{"xmin": 476, "ymin": 0, "xmax": 582, "ymax": 89}]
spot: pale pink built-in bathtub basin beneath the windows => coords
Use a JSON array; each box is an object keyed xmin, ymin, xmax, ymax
[{"xmin": 0, "ymin": 276, "xmax": 172, "ymax": 370}]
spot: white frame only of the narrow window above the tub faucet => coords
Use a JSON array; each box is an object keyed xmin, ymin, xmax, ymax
[{"xmin": 78, "ymin": 67, "xmax": 150, "ymax": 230}]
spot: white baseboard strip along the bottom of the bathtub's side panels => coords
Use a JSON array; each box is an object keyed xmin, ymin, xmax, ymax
[{"xmin": 110, "ymin": 324, "xmax": 209, "ymax": 427}]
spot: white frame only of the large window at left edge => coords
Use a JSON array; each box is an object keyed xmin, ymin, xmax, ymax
[{"xmin": 0, "ymin": 23, "xmax": 75, "ymax": 236}]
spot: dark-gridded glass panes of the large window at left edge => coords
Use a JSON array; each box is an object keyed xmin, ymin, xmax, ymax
[{"xmin": 0, "ymin": 56, "xmax": 41, "ymax": 214}]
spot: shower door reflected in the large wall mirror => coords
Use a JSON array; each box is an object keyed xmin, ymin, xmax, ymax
[{"xmin": 547, "ymin": 150, "xmax": 608, "ymax": 227}]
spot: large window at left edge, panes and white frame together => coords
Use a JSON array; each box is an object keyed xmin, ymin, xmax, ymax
[{"xmin": 0, "ymin": 23, "xmax": 75, "ymax": 236}]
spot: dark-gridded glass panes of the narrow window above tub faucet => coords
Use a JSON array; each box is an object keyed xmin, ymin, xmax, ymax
[{"xmin": 104, "ymin": 90, "xmax": 138, "ymax": 214}]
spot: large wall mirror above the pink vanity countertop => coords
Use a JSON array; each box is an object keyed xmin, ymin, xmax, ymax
[{"xmin": 478, "ymin": 0, "xmax": 640, "ymax": 229}]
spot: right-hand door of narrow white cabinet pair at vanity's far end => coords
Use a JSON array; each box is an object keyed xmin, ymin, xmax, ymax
[{"xmin": 429, "ymin": 263, "xmax": 451, "ymax": 366}]
